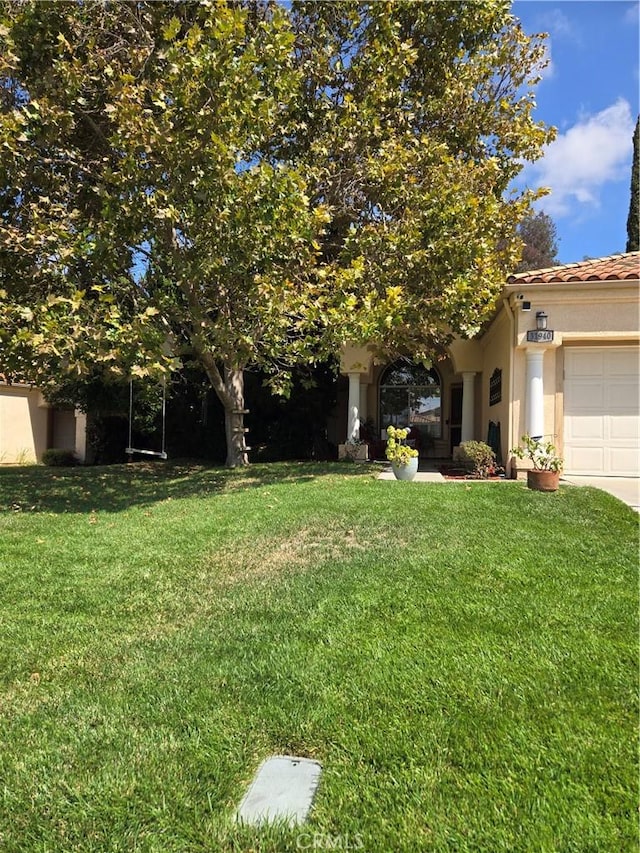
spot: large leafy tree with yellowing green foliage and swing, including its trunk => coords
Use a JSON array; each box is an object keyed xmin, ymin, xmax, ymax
[{"xmin": 0, "ymin": 0, "xmax": 551, "ymax": 465}]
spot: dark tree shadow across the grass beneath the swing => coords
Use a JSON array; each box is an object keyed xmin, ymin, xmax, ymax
[{"xmin": 0, "ymin": 462, "xmax": 371, "ymax": 513}]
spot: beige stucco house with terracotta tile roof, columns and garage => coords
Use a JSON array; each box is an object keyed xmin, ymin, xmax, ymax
[{"xmin": 338, "ymin": 252, "xmax": 640, "ymax": 477}]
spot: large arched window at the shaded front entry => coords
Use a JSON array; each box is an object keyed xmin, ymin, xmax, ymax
[{"xmin": 380, "ymin": 359, "xmax": 442, "ymax": 448}]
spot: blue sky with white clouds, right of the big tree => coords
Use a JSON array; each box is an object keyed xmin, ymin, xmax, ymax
[{"xmin": 512, "ymin": 0, "xmax": 640, "ymax": 263}]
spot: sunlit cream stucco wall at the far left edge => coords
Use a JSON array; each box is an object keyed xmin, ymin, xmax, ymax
[{"xmin": 0, "ymin": 385, "xmax": 49, "ymax": 464}]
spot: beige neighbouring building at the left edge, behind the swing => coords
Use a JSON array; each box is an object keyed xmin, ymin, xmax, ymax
[{"xmin": 0, "ymin": 378, "xmax": 87, "ymax": 464}]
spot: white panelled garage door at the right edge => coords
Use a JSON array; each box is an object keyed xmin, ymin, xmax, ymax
[{"xmin": 564, "ymin": 347, "xmax": 640, "ymax": 477}]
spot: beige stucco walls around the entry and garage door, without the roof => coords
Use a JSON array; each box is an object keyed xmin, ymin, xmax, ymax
[{"xmin": 337, "ymin": 280, "xmax": 640, "ymax": 472}]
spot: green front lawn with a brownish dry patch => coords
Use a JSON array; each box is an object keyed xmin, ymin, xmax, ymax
[{"xmin": 0, "ymin": 464, "xmax": 638, "ymax": 853}]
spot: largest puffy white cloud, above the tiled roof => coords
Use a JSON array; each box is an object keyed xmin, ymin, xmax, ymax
[{"xmin": 523, "ymin": 98, "xmax": 635, "ymax": 217}]
